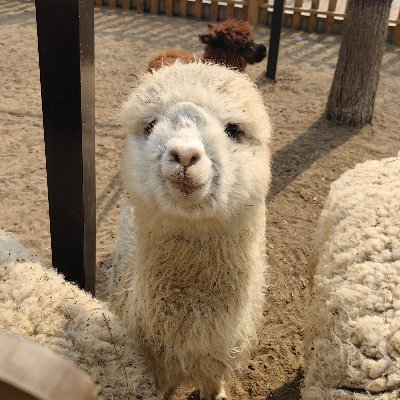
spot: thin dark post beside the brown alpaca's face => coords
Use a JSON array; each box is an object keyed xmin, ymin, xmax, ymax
[{"xmin": 265, "ymin": 0, "xmax": 285, "ymax": 80}]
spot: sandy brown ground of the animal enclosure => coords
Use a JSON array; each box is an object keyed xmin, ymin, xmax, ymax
[{"xmin": 0, "ymin": 0, "xmax": 400, "ymax": 400}]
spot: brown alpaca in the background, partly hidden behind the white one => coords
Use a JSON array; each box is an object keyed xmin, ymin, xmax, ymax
[{"xmin": 148, "ymin": 19, "xmax": 267, "ymax": 72}]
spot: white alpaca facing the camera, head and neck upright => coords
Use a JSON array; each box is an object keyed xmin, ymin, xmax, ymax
[{"xmin": 109, "ymin": 63, "xmax": 271, "ymax": 398}]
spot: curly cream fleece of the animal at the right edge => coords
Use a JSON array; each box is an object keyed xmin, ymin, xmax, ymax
[{"xmin": 303, "ymin": 158, "xmax": 400, "ymax": 400}]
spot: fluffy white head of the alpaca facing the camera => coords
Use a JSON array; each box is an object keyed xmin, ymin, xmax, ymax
[{"xmin": 121, "ymin": 63, "xmax": 271, "ymax": 220}]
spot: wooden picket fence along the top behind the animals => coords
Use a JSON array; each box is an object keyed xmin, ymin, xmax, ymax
[{"xmin": 94, "ymin": 0, "xmax": 400, "ymax": 43}]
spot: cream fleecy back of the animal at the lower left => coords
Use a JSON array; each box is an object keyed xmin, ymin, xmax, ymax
[{"xmin": 0, "ymin": 231, "xmax": 155, "ymax": 400}]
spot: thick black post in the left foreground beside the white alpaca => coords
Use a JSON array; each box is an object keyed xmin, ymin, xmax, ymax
[{"xmin": 35, "ymin": 0, "xmax": 96, "ymax": 294}]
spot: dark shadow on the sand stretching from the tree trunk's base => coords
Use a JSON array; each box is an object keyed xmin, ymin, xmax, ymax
[{"xmin": 267, "ymin": 116, "xmax": 359, "ymax": 202}]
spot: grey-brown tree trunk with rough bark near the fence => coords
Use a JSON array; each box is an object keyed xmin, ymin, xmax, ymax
[{"xmin": 326, "ymin": 0, "xmax": 392, "ymax": 126}]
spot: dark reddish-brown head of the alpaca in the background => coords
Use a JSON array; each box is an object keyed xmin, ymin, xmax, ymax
[{"xmin": 199, "ymin": 19, "xmax": 267, "ymax": 71}]
